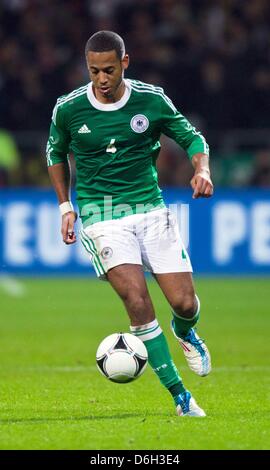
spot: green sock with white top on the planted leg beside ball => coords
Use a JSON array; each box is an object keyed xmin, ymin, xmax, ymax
[{"xmin": 130, "ymin": 319, "xmax": 186, "ymax": 397}]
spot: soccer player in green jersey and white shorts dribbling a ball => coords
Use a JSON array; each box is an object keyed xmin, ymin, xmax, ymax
[{"xmin": 47, "ymin": 31, "xmax": 213, "ymax": 416}]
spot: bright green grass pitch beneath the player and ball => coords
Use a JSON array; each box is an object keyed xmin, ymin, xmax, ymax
[{"xmin": 0, "ymin": 279, "xmax": 270, "ymax": 450}]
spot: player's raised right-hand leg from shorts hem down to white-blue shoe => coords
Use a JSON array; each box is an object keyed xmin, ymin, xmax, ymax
[{"xmin": 154, "ymin": 272, "xmax": 211, "ymax": 376}]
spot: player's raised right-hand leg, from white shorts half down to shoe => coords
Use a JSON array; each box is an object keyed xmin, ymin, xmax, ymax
[{"xmin": 140, "ymin": 209, "xmax": 211, "ymax": 375}]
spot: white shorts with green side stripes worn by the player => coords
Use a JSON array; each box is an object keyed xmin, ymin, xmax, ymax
[{"xmin": 80, "ymin": 208, "xmax": 192, "ymax": 279}]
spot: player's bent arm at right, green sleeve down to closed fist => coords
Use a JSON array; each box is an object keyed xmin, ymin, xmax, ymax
[{"xmin": 161, "ymin": 95, "xmax": 214, "ymax": 199}]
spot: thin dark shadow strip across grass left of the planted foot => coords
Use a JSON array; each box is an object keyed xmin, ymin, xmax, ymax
[{"xmin": 0, "ymin": 413, "xmax": 171, "ymax": 425}]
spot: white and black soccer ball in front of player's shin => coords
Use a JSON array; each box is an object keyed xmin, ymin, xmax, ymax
[{"xmin": 96, "ymin": 333, "xmax": 148, "ymax": 383}]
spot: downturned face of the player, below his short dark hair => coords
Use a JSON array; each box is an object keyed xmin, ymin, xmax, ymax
[{"xmin": 87, "ymin": 50, "xmax": 129, "ymax": 103}]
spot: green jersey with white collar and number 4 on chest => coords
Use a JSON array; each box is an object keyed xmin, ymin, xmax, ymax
[{"xmin": 47, "ymin": 79, "xmax": 208, "ymax": 223}]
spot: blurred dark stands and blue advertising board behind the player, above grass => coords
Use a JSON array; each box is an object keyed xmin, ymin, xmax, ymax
[{"xmin": 0, "ymin": 0, "xmax": 270, "ymax": 274}]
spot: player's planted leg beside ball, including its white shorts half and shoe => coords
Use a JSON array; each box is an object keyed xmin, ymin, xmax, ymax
[{"xmin": 80, "ymin": 216, "xmax": 204, "ymax": 416}]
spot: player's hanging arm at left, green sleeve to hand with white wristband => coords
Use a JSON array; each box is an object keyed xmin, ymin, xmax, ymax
[{"xmin": 46, "ymin": 103, "xmax": 77, "ymax": 244}]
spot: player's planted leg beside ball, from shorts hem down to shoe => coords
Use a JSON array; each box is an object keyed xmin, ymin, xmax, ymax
[{"xmin": 107, "ymin": 264, "xmax": 205, "ymax": 416}]
